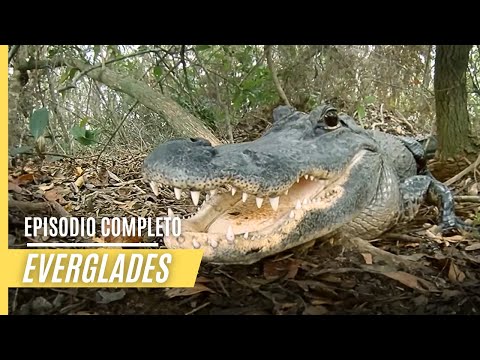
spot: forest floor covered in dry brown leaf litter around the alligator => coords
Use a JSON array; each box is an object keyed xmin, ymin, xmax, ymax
[{"xmin": 9, "ymin": 107, "xmax": 480, "ymax": 315}]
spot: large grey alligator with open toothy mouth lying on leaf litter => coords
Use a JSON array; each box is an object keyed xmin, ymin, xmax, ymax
[{"xmin": 142, "ymin": 105, "xmax": 461, "ymax": 264}]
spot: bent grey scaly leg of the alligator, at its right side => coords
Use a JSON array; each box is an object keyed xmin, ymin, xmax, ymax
[{"xmin": 400, "ymin": 173, "xmax": 466, "ymax": 235}]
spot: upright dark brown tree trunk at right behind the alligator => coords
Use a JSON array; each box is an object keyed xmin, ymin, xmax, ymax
[{"xmin": 434, "ymin": 45, "xmax": 473, "ymax": 160}]
